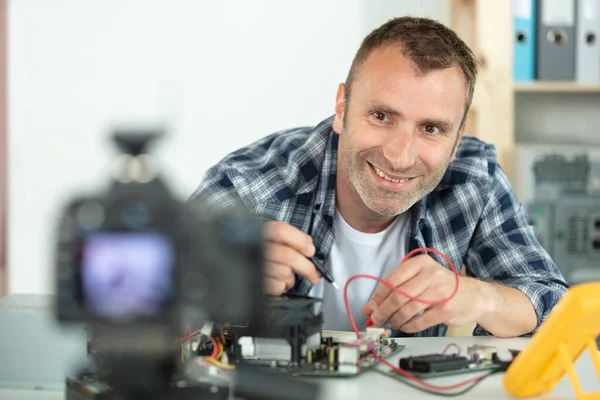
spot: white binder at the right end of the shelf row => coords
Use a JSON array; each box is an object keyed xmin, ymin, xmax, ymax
[{"xmin": 575, "ymin": 0, "xmax": 600, "ymax": 83}]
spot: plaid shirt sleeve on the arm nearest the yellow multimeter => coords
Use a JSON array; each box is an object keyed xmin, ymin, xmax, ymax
[{"xmin": 465, "ymin": 145, "xmax": 568, "ymax": 336}]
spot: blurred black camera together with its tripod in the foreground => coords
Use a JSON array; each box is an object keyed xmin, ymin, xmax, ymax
[{"xmin": 55, "ymin": 130, "xmax": 317, "ymax": 400}]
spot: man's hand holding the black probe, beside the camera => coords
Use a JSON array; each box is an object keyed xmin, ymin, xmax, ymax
[{"xmin": 265, "ymin": 221, "xmax": 321, "ymax": 296}]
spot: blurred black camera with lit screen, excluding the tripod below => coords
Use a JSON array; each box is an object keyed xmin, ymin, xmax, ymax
[{"xmin": 56, "ymin": 128, "xmax": 264, "ymax": 328}]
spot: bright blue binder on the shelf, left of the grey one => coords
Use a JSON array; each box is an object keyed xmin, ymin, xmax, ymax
[{"xmin": 513, "ymin": 0, "xmax": 537, "ymax": 82}]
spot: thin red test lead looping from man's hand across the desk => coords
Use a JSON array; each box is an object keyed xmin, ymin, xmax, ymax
[{"xmin": 344, "ymin": 247, "xmax": 502, "ymax": 394}]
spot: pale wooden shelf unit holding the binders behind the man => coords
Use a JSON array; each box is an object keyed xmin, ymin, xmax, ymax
[{"xmin": 447, "ymin": 0, "xmax": 600, "ymax": 183}]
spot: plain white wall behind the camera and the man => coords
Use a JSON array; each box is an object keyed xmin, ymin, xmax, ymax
[{"xmin": 8, "ymin": 0, "xmax": 448, "ymax": 293}]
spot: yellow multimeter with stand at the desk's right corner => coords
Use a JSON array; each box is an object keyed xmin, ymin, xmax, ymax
[{"xmin": 503, "ymin": 282, "xmax": 600, "ymax": 400}]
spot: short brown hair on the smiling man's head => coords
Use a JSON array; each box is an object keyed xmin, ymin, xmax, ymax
[{"xmin": 345, "ymin": 17, "xmax": 479, "ymax": 127}]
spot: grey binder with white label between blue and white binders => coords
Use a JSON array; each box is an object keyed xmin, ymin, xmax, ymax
[{"xmin": 536, "ymin": 0, "xmax": 577, "ymax": 81}]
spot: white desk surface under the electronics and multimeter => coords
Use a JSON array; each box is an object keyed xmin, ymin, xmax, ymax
[{"xmin": 0, "ymin": 337, "xmax": 600, "ymax": 400}]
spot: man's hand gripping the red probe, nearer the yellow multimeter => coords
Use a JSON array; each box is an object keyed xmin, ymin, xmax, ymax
[{"xmin": 362, "ymin": 254, "xmax": 497, "ymax": 333}]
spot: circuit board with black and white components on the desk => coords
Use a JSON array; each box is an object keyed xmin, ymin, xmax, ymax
[{"xmin": 220, "ymin": 294, "xmax": 404, "ymax": 378}]
